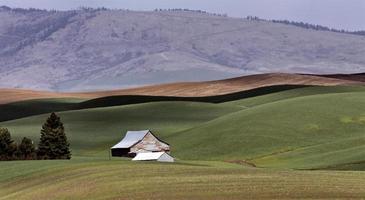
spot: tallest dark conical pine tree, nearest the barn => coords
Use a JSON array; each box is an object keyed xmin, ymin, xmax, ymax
[{"xmin": 37, "ymin": 113, "xmax": 71, "ymax": 159}]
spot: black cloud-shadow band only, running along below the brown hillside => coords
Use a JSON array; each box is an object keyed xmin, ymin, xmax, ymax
[{"xmin": 0, "ymin": 85, "xmax": 309, "ymax": 122}]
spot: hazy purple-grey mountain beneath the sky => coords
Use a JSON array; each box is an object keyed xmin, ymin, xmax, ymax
[{"xmin": 0, "ymin": 7, "xmax": 365, "ymax": 91}]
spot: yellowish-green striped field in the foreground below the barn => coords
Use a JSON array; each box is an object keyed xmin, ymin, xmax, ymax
[{"xmin": 0, "ymin": 159, "xmax": 365, "ymax": 200}]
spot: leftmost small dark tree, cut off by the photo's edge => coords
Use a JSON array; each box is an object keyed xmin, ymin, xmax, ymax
[{"xmin": 0, "ymin": 128, "xmax": 17, "ymax": 160}]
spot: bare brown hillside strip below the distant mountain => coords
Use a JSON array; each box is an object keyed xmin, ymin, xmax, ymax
[{"xmin": 0, "ymin": 73, "xmax": 363, "ymax": 104}]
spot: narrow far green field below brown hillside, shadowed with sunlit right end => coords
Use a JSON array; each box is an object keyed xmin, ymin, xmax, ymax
[{"xmin": 0, "ymin": 85, "xmax": 365, "ymax": 122}]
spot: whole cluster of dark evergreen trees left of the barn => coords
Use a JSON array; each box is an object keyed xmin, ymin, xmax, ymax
[{"xmin": 0, "ymin": 113, "xmax": 71, "ymax": 161}]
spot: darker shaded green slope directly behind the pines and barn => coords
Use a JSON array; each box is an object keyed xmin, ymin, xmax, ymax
[{"xmin": 0, "ymin": 102, "xmax": 238, "ymax": 156}]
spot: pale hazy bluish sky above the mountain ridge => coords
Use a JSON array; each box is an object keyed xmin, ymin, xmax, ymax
[{"xmin": 0, "ymin": 0, "xmax": 365, "ymax": 30}]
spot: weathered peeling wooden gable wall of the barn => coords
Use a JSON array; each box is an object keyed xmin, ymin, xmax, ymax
[{"xmin": 131, "ymin": 133, "xmax": 170, "ymax": 153}]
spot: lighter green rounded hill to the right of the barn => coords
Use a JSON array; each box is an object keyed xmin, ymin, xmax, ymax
[{"xmin": 168, "ymin": 92, "xmax": 365, "ymax": 168}]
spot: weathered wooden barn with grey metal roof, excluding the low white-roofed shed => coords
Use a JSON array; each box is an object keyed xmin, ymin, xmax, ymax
[{"xmin": 111, "ymin": 130, "xmax": 170, "ymax": 157}]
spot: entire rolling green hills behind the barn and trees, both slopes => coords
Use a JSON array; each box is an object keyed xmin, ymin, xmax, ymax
[{"xmin": 0, "ymin": 87, "xmax": 365, "ymax": 168}]
